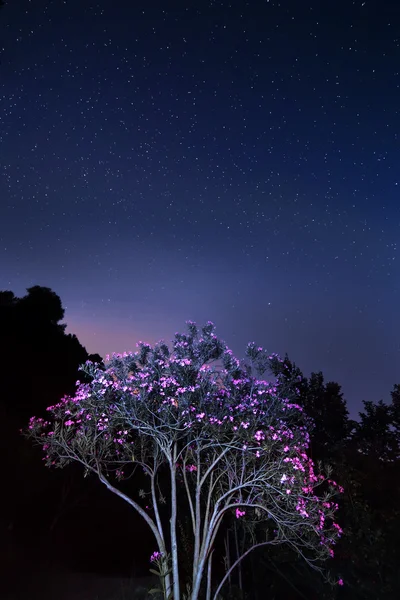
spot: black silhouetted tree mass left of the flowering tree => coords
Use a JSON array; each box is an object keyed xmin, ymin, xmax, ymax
[{"xmin": 0, "ymin": 286, "xmax": 151, "ymax": 584}]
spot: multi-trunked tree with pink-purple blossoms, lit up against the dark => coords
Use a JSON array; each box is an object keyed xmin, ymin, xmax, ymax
[{"xmin": 27, "ymin": 321, "xmax": 341, "ymax": 600}]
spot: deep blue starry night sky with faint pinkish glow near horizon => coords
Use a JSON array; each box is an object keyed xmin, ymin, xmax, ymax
[{"xmin": 0, "ymin": 0, "xmax": 400, "ymax": 416}]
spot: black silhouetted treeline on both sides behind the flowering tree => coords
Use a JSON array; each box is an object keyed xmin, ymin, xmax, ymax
[{"xmin": 0, "ymin": 286, "xmax": 400, "ymax": 600}]
